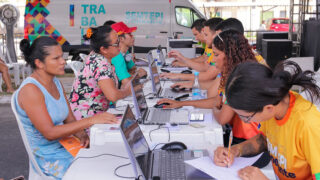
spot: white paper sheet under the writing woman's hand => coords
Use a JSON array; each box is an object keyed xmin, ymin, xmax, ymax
[{"xmin": 185, "ymin": 153, "xmax": 262, "ymax": 180}]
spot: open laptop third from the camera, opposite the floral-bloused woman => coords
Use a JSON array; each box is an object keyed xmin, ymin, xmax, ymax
[{"xmin": 149, "ymin": 56, "xmax": 191, "ymax": 99}]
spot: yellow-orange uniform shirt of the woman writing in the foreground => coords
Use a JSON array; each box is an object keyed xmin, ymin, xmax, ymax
[{"xmin": 260, "ymin": 92, "xmax": 320, "ymax": 180}]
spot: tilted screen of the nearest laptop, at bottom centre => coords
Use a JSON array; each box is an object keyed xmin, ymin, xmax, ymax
[{"xmin": 120, "ymin": 106, "xmax": 150, "ymax": 177}]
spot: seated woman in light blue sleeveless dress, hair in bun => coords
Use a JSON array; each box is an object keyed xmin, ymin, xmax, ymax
[{"xmin": 14, "ymin": 37, "xmax": 118, "ymax": 179}]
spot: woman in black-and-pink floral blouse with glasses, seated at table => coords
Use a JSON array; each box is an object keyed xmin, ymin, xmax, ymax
[{"xmin": 70, "ymin": 26, "xmax": 131, "ymax": 120}]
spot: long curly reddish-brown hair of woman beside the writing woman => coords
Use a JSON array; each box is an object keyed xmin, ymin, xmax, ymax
[{"xmin": 213, "ymin": 30, "xmax": 257, "ymax": 89}]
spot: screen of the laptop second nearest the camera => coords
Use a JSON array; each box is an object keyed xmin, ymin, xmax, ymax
[{"xmin": 131, "ymin": 75, "xmax": 148, "ymax": 119}]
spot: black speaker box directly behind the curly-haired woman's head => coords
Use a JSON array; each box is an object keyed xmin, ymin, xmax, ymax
[{"xmin": 262, "ymin": 39, "xmax": 292, "ymax": 69}]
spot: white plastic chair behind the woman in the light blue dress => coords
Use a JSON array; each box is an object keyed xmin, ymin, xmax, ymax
[{"xmin": 11, "ymin": 91, "xmax": 53, "ymax": 180}]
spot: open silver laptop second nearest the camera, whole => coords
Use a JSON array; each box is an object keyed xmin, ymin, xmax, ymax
[{"xmin": 130, "ymin": 75, "xmax": 189, "ymax": 125}]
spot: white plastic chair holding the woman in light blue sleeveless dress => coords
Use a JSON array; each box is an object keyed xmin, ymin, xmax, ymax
[{"xmin": 11, "ymin": 92, "xmax": 54, "ymax": 180}]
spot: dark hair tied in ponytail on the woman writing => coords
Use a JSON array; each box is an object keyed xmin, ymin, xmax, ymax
[{"xmin": 226, "ymin": 61, "xmax": 320, "ymax": 112}]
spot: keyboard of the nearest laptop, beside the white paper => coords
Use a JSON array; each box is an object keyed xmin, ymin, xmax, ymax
[{"xmin": 160, "ymin": 150, "xmax": 186, "ymax": 180}]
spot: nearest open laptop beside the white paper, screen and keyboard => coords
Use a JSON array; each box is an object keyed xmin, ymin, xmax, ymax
[{"xmin": 120, "ymin": 105, "xmax": 212, "ymax": 180}]
